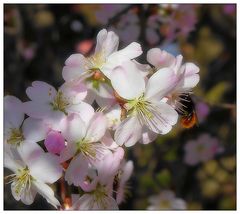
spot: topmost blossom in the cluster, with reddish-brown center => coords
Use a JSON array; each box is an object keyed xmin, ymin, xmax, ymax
[{"xmin": 62, "ymin": 29, "xmax": 142, "ymax": 104}]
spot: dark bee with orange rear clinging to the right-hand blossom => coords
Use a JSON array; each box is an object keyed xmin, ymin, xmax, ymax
[{"xmin": 176, "ymin": 93, "xmax": 198, "ymax": 128}]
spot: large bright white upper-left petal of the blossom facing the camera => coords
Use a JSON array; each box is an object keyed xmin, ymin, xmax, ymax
[{"xmin": 110, "ymin": 61, "xmax": 145, "ymax": 100}]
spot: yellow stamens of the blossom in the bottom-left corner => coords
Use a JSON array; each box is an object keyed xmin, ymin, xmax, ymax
[{"xmin": 5, "ymin": 167, "xmax": 34, "ymax": 196}]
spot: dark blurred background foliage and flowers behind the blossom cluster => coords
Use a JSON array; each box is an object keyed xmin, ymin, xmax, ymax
[{"xmin": 4, "ymin": 4, "xmax": 236, "ymax": 210}]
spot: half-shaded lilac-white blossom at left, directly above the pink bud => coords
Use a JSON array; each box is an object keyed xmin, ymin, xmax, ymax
[{"xmin": 23, "ymin": 81, "xmax": 87, "ymax": 130}]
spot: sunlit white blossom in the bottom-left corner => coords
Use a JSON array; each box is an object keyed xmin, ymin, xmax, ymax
[{"xmin": 4, "ymin": 144, "xmax": 62, "ymax": 208}]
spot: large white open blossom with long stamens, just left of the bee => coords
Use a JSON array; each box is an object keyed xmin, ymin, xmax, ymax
[{"xmin": 110, "ymin": 62, "xmax": 178, "ymax": 146}]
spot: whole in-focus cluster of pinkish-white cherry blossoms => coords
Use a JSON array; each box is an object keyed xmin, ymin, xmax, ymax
[{"xmin": 4, "ymin": 29, "xmax": 199, "ymax": 210}]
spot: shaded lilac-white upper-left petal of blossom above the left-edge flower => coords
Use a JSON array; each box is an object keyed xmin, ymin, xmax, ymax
[{"xmin": 26, "ymin": 81, "xmax": 57, "ymax": 103}]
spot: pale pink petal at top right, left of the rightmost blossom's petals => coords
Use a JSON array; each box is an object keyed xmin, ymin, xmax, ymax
[{"xmin": 147, "ymin": 48, "xmax": 175, "ymax": 69}]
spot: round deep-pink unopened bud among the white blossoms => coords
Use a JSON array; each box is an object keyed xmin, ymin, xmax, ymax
[{"xmin": 44, "ymin": 131, "xmax": 65, "ymax": 154}]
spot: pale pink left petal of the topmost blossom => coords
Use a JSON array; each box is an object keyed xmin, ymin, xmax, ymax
[{"xmin": 62, "ymin": 54, "xmax": 86, "ymax": 82}]
